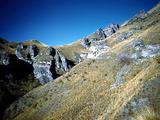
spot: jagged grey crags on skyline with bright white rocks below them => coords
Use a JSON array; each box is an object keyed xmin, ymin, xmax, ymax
[{"xmin": 79, "ymin": 24, "xmax": 119, "ymax": 62}]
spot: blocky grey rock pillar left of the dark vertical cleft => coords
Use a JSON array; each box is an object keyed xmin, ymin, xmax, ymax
[{"xmin": 33, "ymin": 48, "xmax": 55, "ymax": 84}]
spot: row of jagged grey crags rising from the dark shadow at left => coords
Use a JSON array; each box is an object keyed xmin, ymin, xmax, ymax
[{"xmin": 16, "ymin": 44, "xmax": 71, "ymax": 84}]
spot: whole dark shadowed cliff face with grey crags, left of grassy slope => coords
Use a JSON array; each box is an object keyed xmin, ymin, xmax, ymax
[{"xmin": 0, "ymin": 40, "xmax": 73, "ymax": 116}]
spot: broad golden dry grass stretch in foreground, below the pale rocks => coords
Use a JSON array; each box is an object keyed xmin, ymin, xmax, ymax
[{"xmin": 4, "ymin": 55, "xmax": 160, "ymax": 120}]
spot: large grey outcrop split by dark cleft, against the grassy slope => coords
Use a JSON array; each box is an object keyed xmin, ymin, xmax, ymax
[{"xmin": 33, "ymin": 47, "xmax": 69, "ymax": 84}]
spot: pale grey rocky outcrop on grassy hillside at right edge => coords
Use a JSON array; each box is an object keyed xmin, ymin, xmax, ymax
[{"xmin": 117, "ymin": 39, "xmax": 160, "ymax": 62}]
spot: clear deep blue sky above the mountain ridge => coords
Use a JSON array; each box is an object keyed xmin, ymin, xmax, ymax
[{"xmin": 0, "ymin": 0, "xmax": 159, "ymax": 45}]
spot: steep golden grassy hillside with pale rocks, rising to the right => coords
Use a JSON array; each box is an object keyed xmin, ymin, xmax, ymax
[{"xmin": 4, "ymin": 4, "xmax": 160, "ymax": 120}]
